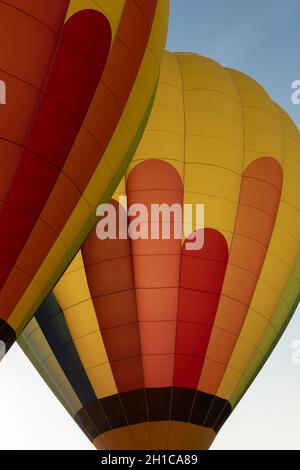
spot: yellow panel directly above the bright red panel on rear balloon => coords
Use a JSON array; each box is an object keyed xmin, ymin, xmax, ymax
[{"xmin": 176, "ymin": 54, "xmax": 244, "ymax": 245}]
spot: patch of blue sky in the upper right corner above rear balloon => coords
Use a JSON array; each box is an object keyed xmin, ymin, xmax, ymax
[{"xmin": 167, "ymin": 0, "xmax": 300, "ymax": 127}]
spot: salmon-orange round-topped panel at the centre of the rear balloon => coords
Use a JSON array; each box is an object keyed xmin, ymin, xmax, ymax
[{"xmin": 127, "ymin": 160, "xmax": 183, "ymax": 388}]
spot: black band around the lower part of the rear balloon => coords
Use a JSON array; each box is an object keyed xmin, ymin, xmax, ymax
[{"xmin": 75, "ymin": 387, "xmax": 232, "ymax": 440}]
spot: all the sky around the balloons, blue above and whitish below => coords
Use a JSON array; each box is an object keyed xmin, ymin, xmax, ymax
[{"xmin": 0, "ymin": 0, "xmax": 300, "ymax": 449}]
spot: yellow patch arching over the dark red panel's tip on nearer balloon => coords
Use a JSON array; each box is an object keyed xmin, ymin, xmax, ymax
[{"xmin": 66, "ymin": 0, "xmax": 126, "ymax": 40}]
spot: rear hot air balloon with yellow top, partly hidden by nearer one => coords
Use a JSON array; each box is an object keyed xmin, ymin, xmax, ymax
[{"xmin": 19, "ymin": 53, "xmax": 300, "ymax": 449}]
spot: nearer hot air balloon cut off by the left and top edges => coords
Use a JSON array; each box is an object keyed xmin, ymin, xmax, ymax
[{"xmin": 0, "ymin": 0, "xmax": 168, "ymax": 356}]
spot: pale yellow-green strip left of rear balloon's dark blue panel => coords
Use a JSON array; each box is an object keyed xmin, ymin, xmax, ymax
[{"xmin": 22, "ymin": 318, "xmax": 82, "ymax": 415}]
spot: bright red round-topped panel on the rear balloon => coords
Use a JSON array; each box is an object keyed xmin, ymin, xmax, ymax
[{"xmin": 174, "ymin": 228, "xmax": 228, "ymax": 388}]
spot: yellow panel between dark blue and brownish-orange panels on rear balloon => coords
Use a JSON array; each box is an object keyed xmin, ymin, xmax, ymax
[{"xmin": 53, "ymin": 253, "xmax": 117, "ymax": 398}]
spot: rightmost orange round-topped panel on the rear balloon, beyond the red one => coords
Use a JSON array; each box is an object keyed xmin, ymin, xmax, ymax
[{"xmin": 198, "ymin": 157, "xmax": 282, "ymax": 394}]
